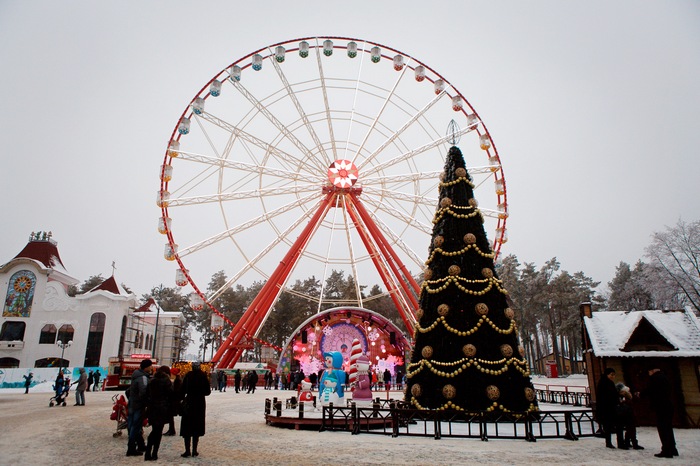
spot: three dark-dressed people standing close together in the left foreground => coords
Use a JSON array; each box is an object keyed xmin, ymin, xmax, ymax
[{"xmin": 126, "ymin": 359, "xmax": 211, "ymax": 461}]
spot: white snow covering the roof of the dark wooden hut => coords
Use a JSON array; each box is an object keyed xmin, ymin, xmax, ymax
[{"xmin": 583, "ymin": 310, "xmax": 700, "ymax": 357}]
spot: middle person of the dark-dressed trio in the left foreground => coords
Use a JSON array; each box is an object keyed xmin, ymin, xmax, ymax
[{"xmin": 143, "ymin": 366, "xmax": 174, "ymax": 461}]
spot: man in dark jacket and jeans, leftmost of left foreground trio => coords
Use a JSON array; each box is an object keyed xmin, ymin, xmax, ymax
[{"xmin": 126, "ymin": 359, "xmax": 153, "ymax": 456}]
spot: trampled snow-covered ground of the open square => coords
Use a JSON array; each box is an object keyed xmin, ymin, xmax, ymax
[{"xmin": 0, "ymin": 380, "xmax": 700, "ymax": 466}]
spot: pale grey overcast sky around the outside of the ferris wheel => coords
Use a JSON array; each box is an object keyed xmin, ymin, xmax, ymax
[{"xmin": 0, "ymin": 0, "xmax": 700, "ymax": 295}]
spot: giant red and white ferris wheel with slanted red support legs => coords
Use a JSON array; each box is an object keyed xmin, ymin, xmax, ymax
[{"xmin": 157, "ymin": 37, "xmax": 508, "ymax": 364}]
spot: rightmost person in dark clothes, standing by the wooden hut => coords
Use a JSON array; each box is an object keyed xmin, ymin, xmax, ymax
[{"xmin": 645, "ymin": 368, "xmax": 678, "ymax": 458}]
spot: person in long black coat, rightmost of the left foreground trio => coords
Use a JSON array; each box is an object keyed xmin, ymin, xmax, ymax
[{"xmin": 180, "ymin": 362, "xmax": 211, "ymax": 458}]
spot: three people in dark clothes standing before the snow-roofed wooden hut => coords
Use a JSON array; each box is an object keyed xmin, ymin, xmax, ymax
[{"xmin": 596, "ymin": 367, "xmax": 678, "ymax": 458}]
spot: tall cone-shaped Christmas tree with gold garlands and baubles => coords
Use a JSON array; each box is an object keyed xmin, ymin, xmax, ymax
[{"xmin": 406, "ymin": 146, "xmax": 537, "ymax": 413}]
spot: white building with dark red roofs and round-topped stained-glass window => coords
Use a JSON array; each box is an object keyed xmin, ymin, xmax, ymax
[{"xmin": 0, "ymin": 232, "xmax": 185, "ymax": 368}]
